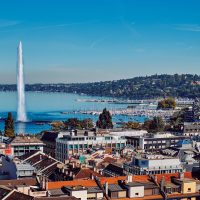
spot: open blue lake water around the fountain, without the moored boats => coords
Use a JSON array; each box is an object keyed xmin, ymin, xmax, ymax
[{"xmin": 0, "ymin": 92, "xmax": 145, "ymax": 134}]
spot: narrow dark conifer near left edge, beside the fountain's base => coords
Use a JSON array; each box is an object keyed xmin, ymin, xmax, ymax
[{"xmin": 4, "ymin": 112, "xmax": 15, "ymax": 138}]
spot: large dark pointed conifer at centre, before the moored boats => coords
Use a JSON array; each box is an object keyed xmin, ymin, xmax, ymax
[{"xmin": 96, "ymin": 108, "xmax": 113, "ymax": 129}]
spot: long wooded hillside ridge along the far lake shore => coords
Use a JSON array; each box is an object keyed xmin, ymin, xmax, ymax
[{"xmin": 0, "ymin": 74, "xmax": 200, "ymax": 99}]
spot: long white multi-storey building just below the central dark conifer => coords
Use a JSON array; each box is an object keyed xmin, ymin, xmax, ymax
[{"xmin": 56, "ymin": 131, "xmax": 126, "ymax": 162}]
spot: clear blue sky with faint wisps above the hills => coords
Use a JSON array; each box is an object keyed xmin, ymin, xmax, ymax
[{"xmin": 0, "ymin": 0, "xmax": 200, "ymax": 83}]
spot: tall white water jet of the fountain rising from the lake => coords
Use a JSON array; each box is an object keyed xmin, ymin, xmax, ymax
[{"xmin": 17, "ymin": 41, "xmax": 27, "ymax": 122}]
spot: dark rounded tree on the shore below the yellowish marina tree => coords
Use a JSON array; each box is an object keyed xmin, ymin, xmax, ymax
[{"xmin": 144, "ymin": 117, "xmax": 165, "ymax": 133}]
